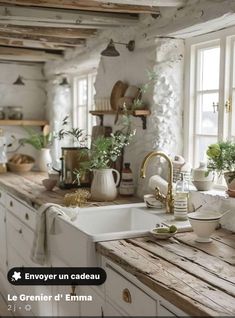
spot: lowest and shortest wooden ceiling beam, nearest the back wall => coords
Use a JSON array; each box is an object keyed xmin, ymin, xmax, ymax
[{"xmin": 0, "ymin": 37, "xmax": 75, "ymax": 51}]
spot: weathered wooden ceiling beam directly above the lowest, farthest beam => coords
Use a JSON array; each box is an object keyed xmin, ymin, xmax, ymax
[{"xmin": 0, "ymin": 31, "xmax": 86, "ymax": 46}]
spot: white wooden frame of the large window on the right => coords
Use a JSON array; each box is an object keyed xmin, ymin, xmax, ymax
[{"xmin": 184, "ymin": 27, "xmax": 235, "ymax": 167}]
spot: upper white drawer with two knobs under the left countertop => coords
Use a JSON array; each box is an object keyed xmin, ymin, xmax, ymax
[{"xmin": 6, "ymin": 194, "xmax": 36, "ymax": 229}]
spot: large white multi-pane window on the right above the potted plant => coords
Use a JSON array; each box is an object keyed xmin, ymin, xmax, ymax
[{"xmin": 184, "ymin": 28, "xmax": 235, "ymax": 167}]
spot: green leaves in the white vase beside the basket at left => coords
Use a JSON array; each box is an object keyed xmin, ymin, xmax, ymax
[{"xmin": 19, "ymin": 125, "xmax": 53, "ymax": 150}]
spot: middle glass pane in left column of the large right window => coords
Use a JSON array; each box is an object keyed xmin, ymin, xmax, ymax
[{"xmin": 197, "ymin": 93, "xmax": 219, "ymax": 135}]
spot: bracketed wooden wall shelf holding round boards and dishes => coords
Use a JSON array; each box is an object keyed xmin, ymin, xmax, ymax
[{"xmin": 90, "ymin": 109, "xmax": 151, "ymax": 129}]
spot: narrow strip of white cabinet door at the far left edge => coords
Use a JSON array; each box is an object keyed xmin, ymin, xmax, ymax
[{"xmin": 0, "ymin": 204, "xmax": 7, "ymax": 273}]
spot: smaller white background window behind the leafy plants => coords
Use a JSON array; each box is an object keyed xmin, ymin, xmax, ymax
[{"xmin": 73, "ymin": 73, "xmax": 96, "ymax": 141}]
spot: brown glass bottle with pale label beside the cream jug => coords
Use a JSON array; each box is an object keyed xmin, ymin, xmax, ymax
[{"xmin": 119, "ymin": 162, "xmax": 135, "ymax": 196}]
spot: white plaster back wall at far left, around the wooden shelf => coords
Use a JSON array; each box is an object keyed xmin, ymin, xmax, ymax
[{"xmin": 0, "ymin": 63, "xmax": 47, "ymax": 158}]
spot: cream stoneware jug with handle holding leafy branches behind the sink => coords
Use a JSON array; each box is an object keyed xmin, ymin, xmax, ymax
[{"xmin": 91, "ymin": 169, "xmax": 120, "ymax": 201}]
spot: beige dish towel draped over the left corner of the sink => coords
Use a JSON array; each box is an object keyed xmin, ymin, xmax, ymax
[{"xmin": 31, "ymin": 203, "xmax": 77, "ymax": 265}]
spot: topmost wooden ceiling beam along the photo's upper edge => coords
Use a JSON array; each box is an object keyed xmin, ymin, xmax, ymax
[{"xmin": 0, "ymin": 0, "xmax": 159, "ymax": 14}]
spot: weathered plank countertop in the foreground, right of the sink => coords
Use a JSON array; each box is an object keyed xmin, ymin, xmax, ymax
[{"xmin": 97, "ymin": 229, "xmax": 235, "ymax": 317}]
